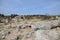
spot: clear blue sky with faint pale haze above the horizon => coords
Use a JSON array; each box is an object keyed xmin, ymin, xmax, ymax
[{"xmin": 0, "ymin": 0, "xmax": 60, "ymax": 15}]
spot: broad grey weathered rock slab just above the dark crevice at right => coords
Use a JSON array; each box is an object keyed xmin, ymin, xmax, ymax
[{"xmin": 32, "ymin": 20, "xmax": 60, "ymax": 30}]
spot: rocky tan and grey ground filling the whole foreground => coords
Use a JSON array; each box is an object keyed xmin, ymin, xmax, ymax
[{"xmin": 0, "ymin": 17, "xmax": 60, "ymax": 40}]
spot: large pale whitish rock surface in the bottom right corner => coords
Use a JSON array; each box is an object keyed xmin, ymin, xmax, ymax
[{"xmin": 35, "ymin": 30, "xmax": 60, "ymax": 40}]
